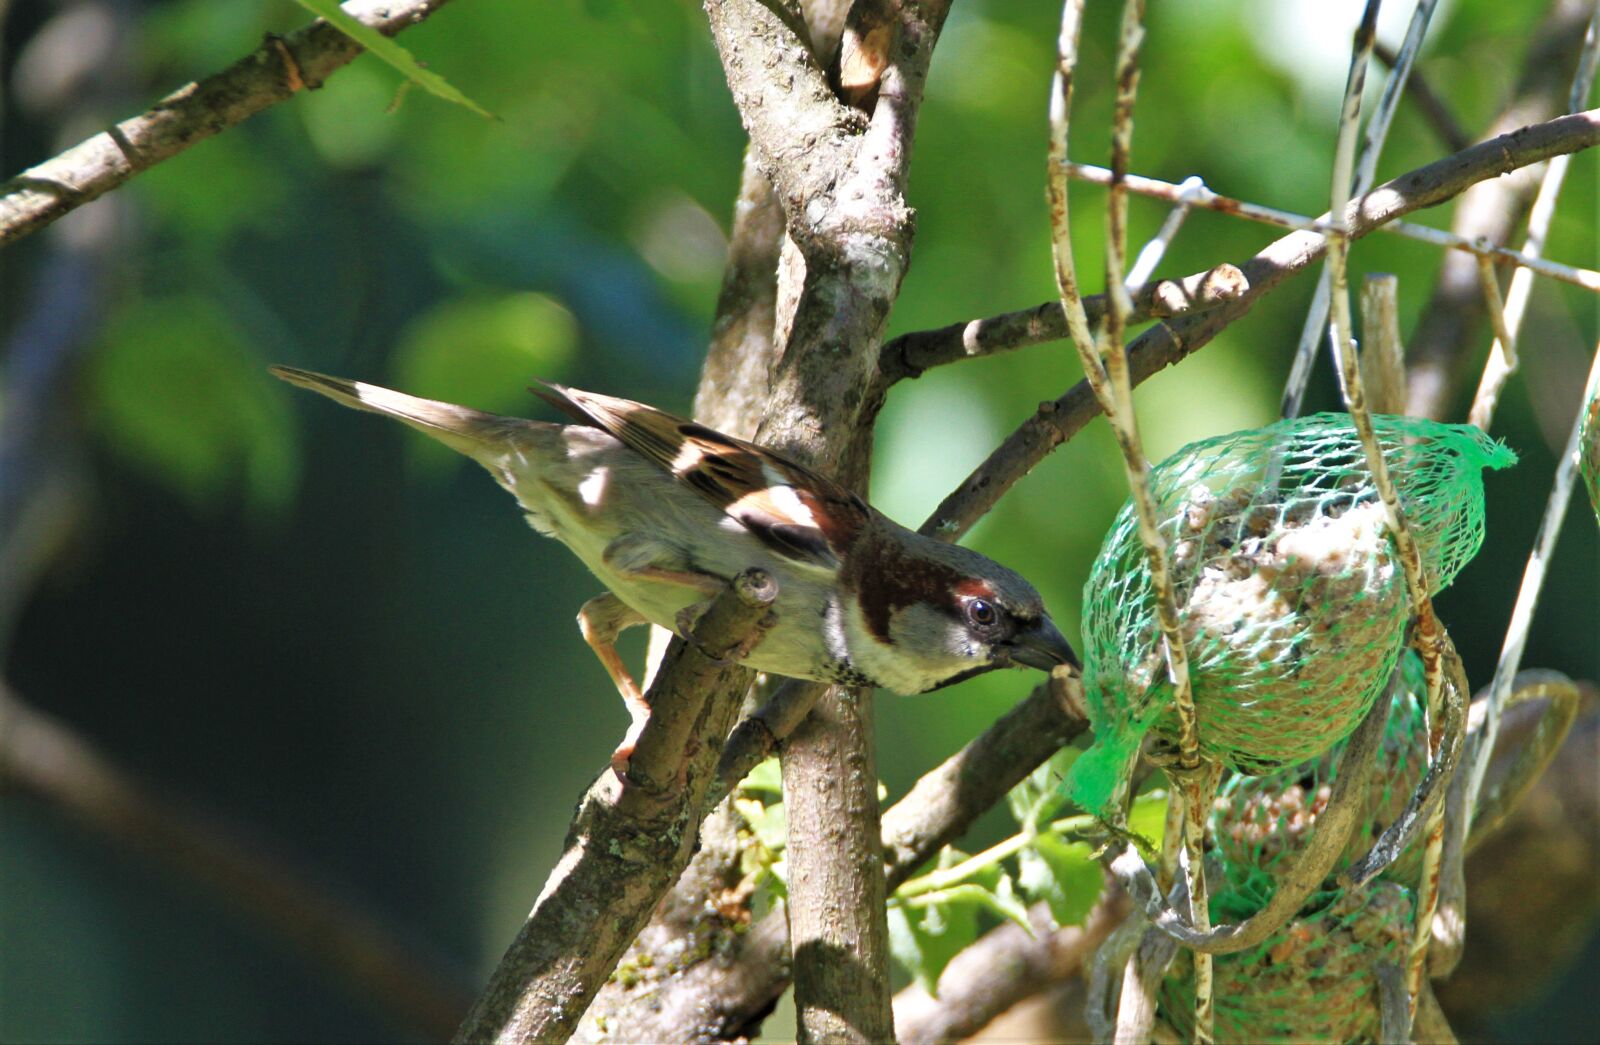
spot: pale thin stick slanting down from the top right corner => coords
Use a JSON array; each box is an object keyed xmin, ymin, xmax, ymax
[{"xmin": 1467, "ymin": 5, "xmax": 1600, "ymax": 430}]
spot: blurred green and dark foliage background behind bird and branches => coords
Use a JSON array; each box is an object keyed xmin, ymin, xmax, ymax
[{"xmin": 0, "ymin": 0, "xmax": 1600, "ymax": 1040}]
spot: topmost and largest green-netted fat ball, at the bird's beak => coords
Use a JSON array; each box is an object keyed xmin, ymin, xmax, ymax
[{"xmin": 1064, "ymin": 413, "xmax": 1515, "ymax": 819}]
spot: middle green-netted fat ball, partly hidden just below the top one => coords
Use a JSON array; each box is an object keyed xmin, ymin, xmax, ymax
[{"xmin": 1211, "ymin": 650, "xmax": 1427, "ymax": 909}]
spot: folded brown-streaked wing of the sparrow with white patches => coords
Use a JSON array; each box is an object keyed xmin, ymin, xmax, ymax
[{"xmin": 530, "ymin": 382, "xmax": 870, "ymax": 568}]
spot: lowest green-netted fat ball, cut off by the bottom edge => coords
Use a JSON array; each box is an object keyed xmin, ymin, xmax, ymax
[{"xmin": 1158, "ymin": 882, "xmax": 1414, "ymax": 1042}]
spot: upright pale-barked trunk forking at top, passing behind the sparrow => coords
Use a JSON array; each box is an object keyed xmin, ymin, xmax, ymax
[{"xmin": 706, "ymin": 0, "xmax": 947, "ymax": 1040}]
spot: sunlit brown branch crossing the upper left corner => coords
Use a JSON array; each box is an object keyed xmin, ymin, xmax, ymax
[{"xmin": 0, "ymin": 0, "xmax": 460, "ymax": 246}]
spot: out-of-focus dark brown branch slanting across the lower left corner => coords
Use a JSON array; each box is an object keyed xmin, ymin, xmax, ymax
[{"xmin": 0, "ymin": 685, "xmax": 472, "ymax": 1039}]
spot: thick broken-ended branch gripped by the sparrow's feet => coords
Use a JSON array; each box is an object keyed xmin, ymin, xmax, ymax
[{"xmin": 456, "ymin": 570, "xmax": 778, "ymax": 1042}]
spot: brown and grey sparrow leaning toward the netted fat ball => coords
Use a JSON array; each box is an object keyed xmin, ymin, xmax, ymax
[{"xmin": 270, "ymin": 366, "xmax": 1078, "ymax": 773}]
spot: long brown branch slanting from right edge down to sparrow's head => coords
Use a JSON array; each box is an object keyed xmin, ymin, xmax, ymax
[{"xmin": 922, "ymin": 109, "xmax": 1600, "ymax": 541}]
